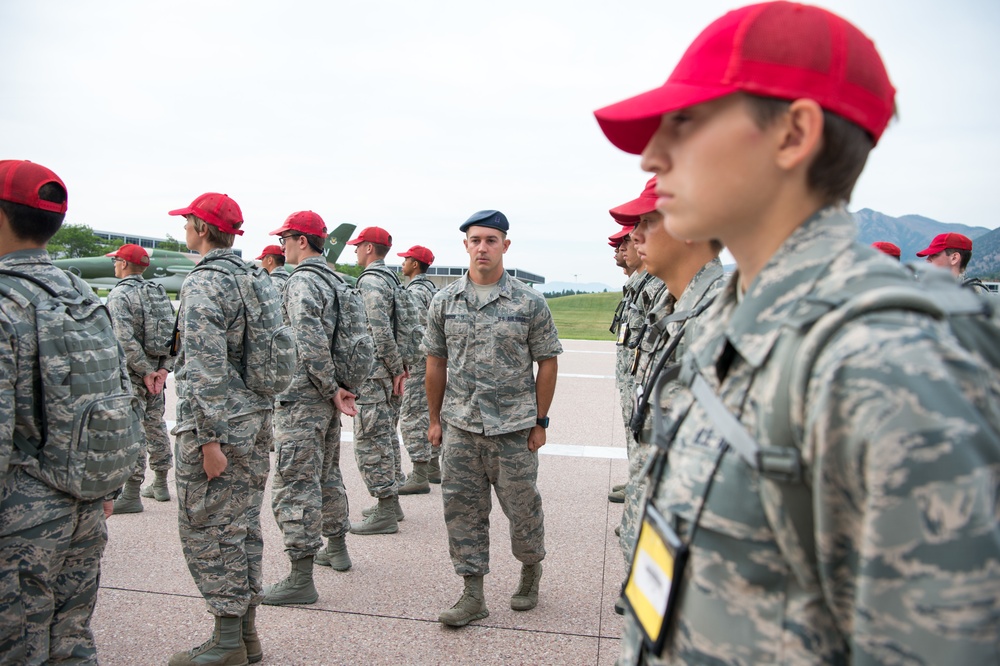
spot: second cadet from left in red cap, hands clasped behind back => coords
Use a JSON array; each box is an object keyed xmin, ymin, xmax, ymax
[{"xmin": 106, "ymin": 243, "xmax": 175, "ymax": 513}]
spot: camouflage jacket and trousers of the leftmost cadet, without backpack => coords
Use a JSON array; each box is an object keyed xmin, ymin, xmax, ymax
[{"xmin": 0, "ymin": 250, "xmax": 109, "ymax": 664}]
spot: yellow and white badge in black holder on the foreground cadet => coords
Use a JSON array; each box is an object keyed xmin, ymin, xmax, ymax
[{"xmin": 625, "ymin": 501, "xmax": 688, "ymax": 655}]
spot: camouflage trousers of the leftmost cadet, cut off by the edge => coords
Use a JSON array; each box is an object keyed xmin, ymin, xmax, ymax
[{"xmin": 0, "ymin": 466, "xmax": 108, "ymax": 664}]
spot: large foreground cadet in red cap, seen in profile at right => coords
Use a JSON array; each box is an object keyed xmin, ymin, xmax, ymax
[{"xmin": 596, "ymin": 2, "xmax": 1000, "ymax": 664}]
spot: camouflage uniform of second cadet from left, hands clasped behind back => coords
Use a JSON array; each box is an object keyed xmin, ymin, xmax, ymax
[{"xmin": 108, "ymin": 275, "xmax": 174, "ymax": 483}]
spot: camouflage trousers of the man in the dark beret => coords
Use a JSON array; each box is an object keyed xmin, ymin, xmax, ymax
[{"xmin": 441, "ymin": 424, "xmax": 545, "ymax": 576}]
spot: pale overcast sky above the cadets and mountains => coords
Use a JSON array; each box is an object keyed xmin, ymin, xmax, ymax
[{"xmin": 0, "ymin": 0, "xmax": 1000, "ymax": 286}]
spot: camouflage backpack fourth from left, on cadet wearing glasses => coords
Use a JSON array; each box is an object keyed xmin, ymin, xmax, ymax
[{"xmin": 292, "ymin": 264, "xmax": 375, "ymax": 391}]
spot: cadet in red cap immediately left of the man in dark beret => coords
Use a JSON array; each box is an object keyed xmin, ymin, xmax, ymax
[{"xmin": 396, "ymin": 245, "xmax": 441, "ymax": 495}]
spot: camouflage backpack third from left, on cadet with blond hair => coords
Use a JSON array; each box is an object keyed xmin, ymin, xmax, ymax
[{"xmin": 192, "ymin": 256, "xmax": 296, "ymax": 398}]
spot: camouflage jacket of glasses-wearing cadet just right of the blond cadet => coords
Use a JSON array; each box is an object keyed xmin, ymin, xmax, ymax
[{"xmin": 272, "ymin": 256, "xmax": 337, "ymax": 402}]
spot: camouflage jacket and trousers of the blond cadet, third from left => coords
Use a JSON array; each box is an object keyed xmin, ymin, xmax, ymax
[{"xmin": 174, "ymin": 249, "xmax": 272, "ymax": 617}]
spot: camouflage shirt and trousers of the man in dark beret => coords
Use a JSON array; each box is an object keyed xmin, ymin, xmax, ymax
[{"xmin": 421, "ymin": 272, "xmax": 562, "ymax": 576}]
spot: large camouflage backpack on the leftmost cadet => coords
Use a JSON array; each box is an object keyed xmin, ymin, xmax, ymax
[{"xmin": 0, "ymin": 269, "xmax": 142, "ymax": 500}]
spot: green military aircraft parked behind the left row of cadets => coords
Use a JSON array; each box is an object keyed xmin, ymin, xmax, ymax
[{"xmin": 52, "ymin": 224, "xmax": 356, "ymax": 294}]
